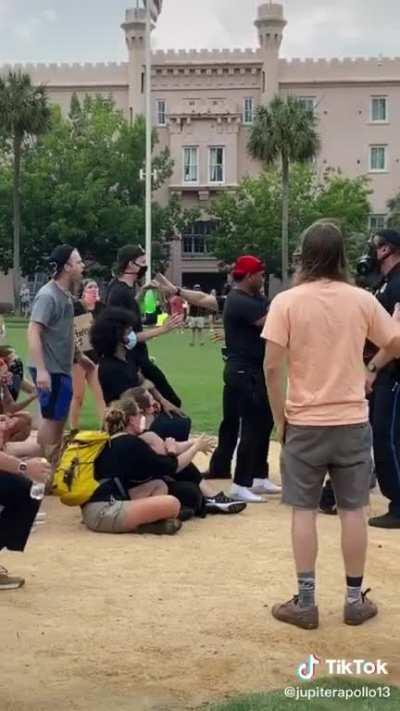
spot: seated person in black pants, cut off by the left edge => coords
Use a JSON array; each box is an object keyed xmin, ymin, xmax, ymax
[{"xmin": 0, "ymin": 415, "xmax": 51, "ymax": 590}]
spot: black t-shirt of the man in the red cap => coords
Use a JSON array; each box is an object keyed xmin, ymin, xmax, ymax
[{"xmin": 224, "ymin": 289, "xmax": 268, "ymax": 369}]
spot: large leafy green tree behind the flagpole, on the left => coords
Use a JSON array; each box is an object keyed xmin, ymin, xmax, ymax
[{"xmin": 0, "ymin": 96, "xmax": 192, "ymax": 273}]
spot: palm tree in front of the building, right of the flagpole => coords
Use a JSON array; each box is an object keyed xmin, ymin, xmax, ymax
[{"xmin": 248, "ymin": 96, "xmax": 320, "ymax": 286}]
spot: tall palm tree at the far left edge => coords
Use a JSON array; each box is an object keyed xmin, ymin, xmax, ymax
[{"xmin": 0, "ymin": 72, "xmax": 51, "ymax": 308}]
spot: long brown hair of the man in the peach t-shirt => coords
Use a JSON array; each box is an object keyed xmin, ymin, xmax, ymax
[{"xmin": 293, "ymin": 220, "xmax": 350, "ymax": 286}]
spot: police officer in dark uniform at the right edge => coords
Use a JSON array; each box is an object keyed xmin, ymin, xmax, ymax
[{"xmin": 367, "ymin": 229, "xmax": 400, "ymax": 529}]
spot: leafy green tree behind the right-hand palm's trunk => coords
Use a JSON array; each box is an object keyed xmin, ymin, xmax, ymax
[{"xmin": 211, "ymin": 164, "xmax": 371, "ymax": 277}]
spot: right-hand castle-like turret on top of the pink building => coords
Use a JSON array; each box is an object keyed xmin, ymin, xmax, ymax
[{"xmin": 255, "ymin": 2, "xmax": 287, "ymax": 103}]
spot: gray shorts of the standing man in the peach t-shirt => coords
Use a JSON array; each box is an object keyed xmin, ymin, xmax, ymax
[{"xmin": 281, "ymin": 422, "xmax": 373, "ymax": 511}]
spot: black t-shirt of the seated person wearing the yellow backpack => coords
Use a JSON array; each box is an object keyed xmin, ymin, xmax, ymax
[{"xmin": 90, "ymin": 434, "xmax": 178, "ymax": 503}]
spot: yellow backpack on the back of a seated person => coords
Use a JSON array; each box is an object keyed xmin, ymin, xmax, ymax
[{"xmin": 52, "ymin": 431, "xmax": 111, "ymax": 506}]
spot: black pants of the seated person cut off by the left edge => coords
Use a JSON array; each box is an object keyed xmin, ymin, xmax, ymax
[{"xmin": 0, "ymin": 472, "xmax": 41, "ymax": 551}]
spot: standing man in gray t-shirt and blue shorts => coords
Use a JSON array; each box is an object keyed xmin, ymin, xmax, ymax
[{"xmin": 28, "ymin": 244, "xmax": 85, "ymax": 453}]
